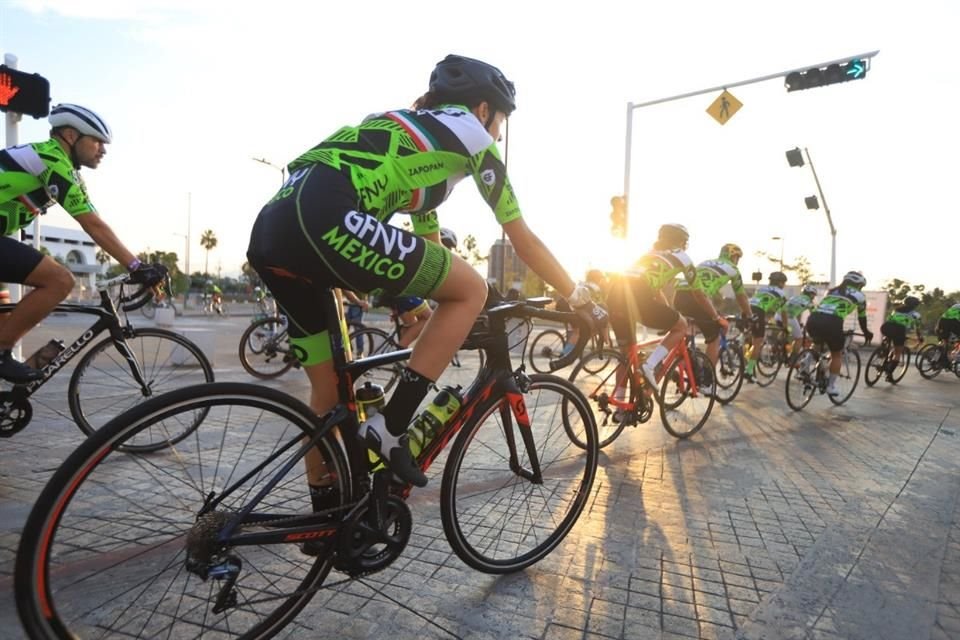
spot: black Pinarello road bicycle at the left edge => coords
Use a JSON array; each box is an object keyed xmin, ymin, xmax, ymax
[{"xmin": 0, "ymin": 275, "xmax": 213, "ymax": 452}]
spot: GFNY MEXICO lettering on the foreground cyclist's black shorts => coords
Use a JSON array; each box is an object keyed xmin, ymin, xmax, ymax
[{"xmin": 323, "ymin": 211, "xmax": 417, "ymax": 280}]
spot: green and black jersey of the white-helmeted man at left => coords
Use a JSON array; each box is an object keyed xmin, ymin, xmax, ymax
[{"xmin": 0, "ymin": 139, "xmax": 96, "ymax": 236}]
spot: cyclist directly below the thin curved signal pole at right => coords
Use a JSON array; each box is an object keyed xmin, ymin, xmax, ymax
[{"xmin": 807, "ymin": 271, "xmax": 873, "ymax": 396}]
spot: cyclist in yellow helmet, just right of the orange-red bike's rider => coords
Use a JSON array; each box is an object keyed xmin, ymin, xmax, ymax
[{"xmin": 673, "ymin": 242, "xmax": 750, "ymax": 365}]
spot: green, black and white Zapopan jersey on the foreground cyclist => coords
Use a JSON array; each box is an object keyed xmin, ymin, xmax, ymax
[{"xmin": 288, "ymin": 105, "xmax": 521, "ymax": 234}]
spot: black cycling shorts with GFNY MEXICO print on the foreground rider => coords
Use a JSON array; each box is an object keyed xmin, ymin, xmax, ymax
[{"xmin": 247, "ymin": 164, "xmax": 451, "ymax": 365}]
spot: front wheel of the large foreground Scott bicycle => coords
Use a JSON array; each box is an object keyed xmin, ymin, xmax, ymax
[{"xmin": 440, "ymin": 374, "xmax": 597, "ymax": 573}]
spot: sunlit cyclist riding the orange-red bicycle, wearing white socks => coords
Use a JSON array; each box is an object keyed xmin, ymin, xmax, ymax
[{"xmin": 607, "ymin": 224, "xmax": 699, "ymax": 389}]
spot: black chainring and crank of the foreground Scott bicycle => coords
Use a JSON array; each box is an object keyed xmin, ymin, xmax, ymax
[{"xmin": 334, "ymin": 495, "xmax": 413, "ymax": 576}]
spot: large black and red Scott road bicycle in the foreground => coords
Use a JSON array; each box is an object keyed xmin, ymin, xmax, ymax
[{"xmin": 14, "ymin": 292, "xmax": 598, "ymax": 640}]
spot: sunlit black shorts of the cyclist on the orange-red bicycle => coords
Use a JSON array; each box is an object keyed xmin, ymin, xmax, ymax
[{"xmin": 607, "ymin": 276, "xmax": 680, "ymax": 346}]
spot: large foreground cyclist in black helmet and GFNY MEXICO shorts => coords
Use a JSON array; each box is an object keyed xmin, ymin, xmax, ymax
[{"xmin": 247, "ymin": 55, "xmax": 604, "ymax": 490}]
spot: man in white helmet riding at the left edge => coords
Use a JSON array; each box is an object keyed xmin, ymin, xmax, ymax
[{"xmin": 0, "ymin": 104, "xmax": 167, "ymax": 383}]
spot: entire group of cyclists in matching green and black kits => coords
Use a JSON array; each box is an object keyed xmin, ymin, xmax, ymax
[{"xmin": 0, "ymin": 54, "xmax": 960, "ymax": 492}]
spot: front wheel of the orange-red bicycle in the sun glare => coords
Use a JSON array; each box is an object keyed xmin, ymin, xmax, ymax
[{"xmin": 659, "ymin": 349, "xmax": 716, "ymax": 439}]
